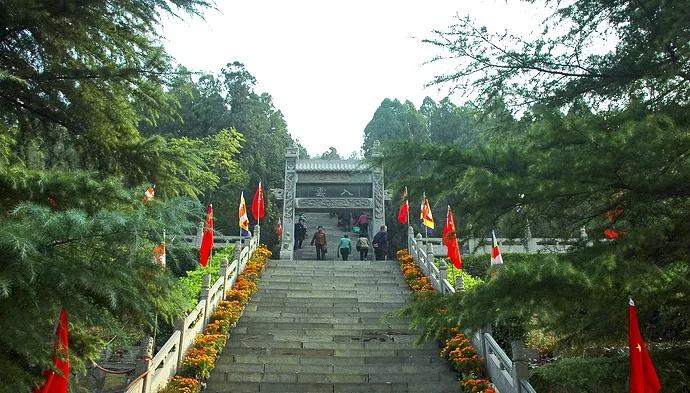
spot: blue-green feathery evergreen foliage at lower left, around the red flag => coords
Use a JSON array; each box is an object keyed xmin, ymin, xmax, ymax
[{"xmin": 0, "ymin": 173, "xmax": 202, "ymax": 390}]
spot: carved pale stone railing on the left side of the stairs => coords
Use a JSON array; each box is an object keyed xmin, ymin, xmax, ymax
[{"xmin": 125, "ymin": 226, "xmax": 259, "ymax": 393}]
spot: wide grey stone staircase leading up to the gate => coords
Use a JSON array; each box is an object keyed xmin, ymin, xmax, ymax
[{"xmin": 206, "ymin": 258, "xmax": 459, "ymax": 393}]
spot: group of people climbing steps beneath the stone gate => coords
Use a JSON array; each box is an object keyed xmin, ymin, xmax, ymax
[{"xmin": 294, "ymin": 213, "xmax": 388, "ymax": 261}]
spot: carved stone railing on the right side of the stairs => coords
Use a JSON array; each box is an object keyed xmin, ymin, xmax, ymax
[{"xmin": 407, "ymin": 227, "xmax": 535, "ymax": 393}]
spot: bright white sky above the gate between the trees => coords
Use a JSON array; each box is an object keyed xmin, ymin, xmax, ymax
[{"xmin": 162, "ymin": 0, "xmax": 545, "ymax": 156}]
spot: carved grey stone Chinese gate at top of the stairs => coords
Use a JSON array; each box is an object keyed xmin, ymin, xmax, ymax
[{"xmin": 274, "ymin": 142, "xmax": 390, "ymax": 259}]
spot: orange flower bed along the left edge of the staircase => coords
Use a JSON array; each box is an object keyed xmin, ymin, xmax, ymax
[{"xmin": 160, "ymin": 245, "xmax": 271, "ymax": 393}]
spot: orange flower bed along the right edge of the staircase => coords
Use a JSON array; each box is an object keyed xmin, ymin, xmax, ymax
[{"xmin": 397, "ymin": 249, "xmax": 496, "ymax": 393}]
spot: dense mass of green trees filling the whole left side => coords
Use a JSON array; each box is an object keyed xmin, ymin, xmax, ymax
[{"xmin": 0, "ymin": 0, "xmax": 293, "ymax": 391}]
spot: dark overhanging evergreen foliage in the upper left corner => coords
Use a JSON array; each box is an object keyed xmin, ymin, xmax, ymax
[{"xmin": 0, "ymin": 0, "xmax": 210, "ymax": 168}]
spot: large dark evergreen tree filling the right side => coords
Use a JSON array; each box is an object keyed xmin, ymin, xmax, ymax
[{"xmin": 378, "ymin": 0, "xmax": 690, "ymax": 392}]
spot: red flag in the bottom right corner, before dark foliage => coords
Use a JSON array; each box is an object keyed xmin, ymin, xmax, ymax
[{"xmin": 628, "ymin": 299, "xmax": 661, "ymax": 393}]
